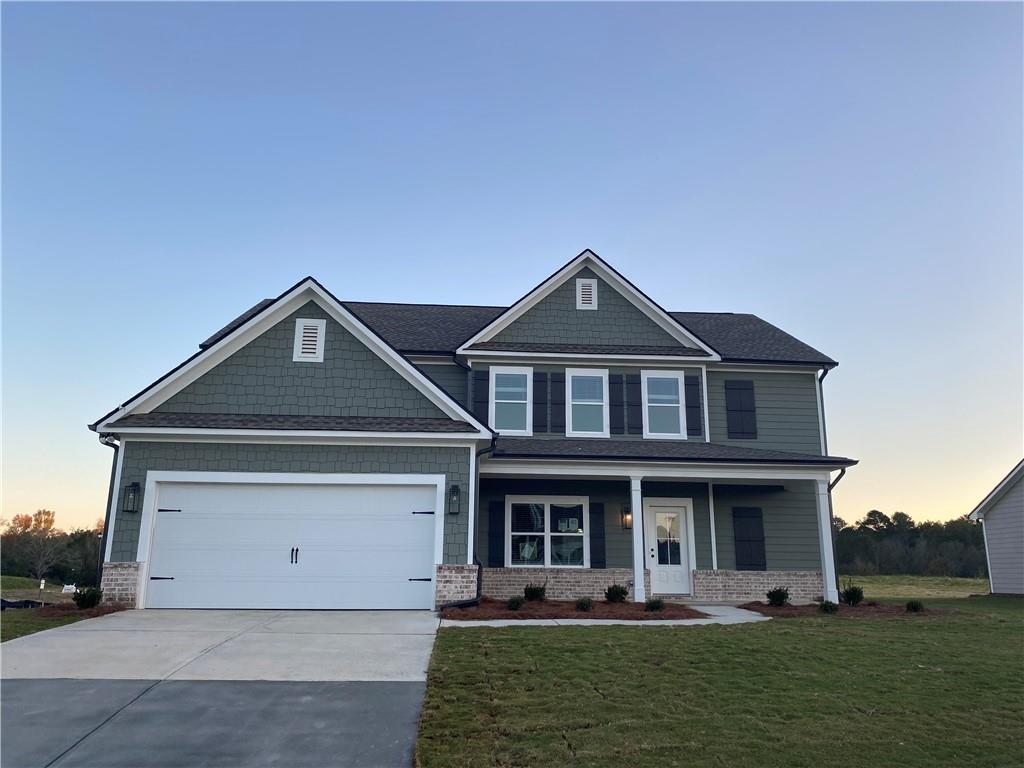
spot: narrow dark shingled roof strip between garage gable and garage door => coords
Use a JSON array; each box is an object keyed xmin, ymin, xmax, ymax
[{"xmin": 110, "ymin": 411, "xmax": 476, "ymax": 433}]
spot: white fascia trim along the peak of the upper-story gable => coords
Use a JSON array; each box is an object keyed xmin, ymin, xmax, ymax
[{"xmin": 457, "ymin": 250, "xmax": 721, "ymax": 360}]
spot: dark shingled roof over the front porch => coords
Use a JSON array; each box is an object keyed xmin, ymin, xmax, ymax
[{"xmin": 492, "ymin": 437, "xmax": 857, "ymax": 467}]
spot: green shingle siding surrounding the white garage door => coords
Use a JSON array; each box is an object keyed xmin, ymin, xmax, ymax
[{"xmin": 111, "ymin": 440, "xmax": 470, "ymax": 563}]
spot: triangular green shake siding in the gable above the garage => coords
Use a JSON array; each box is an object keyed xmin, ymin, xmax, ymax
[{"xmin": 155, "ymin": 301, "xmax": 445, "ymax": 418}]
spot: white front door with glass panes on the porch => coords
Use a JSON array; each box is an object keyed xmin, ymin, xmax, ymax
[{"xmin": 643, "ymin": 499, "xmax": 692, "ymax": 595}]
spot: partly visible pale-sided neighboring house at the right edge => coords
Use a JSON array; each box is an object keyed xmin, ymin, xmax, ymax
[{"xmin": 971, "ymin": 461, "xmax": 1024, "ymax": 595}]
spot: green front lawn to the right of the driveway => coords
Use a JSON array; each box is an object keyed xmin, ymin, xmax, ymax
[{"xmin": 417, "ymin": 598, "xmax": 1024, "ymax": 768}]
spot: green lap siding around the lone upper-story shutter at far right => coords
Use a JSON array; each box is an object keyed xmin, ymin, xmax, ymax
[{"xmin": 708, "ymin": 368, "xmax": 821, "ymax": 456}]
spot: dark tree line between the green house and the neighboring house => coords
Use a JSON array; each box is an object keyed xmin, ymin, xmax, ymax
[{"xmin": 833, "ymin": 509, "xmax": 988, "ymax": 577}]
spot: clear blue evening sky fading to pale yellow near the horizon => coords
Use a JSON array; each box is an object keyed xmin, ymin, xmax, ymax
[{"xmin": 0, "ymin": 3, "xmax": 1024, "ymax": 527}]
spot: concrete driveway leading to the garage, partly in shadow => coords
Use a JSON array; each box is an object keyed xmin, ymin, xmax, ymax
[{"xmin": 0, "ymin": 610, "xmax": 438, "ymax": 768}]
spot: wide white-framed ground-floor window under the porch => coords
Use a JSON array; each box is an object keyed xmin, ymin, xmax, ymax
[{"xmin": 505, "ymin": 496, "xmax": 590, "ymax": 568}]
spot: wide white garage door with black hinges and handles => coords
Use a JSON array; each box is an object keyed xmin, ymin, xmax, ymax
[{"xmin": 145, "ymin": 482, "xmax": 436, "ymax": 608}]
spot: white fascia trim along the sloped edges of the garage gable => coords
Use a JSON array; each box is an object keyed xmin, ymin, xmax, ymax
[{"xmin": 96, "ymin": 280, "xmax": 492, "ymax": 437}]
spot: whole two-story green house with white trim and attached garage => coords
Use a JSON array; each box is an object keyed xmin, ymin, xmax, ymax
[{"xmin": 90, "ymin": 251, "xmax": 855, "ymax": 608}]
